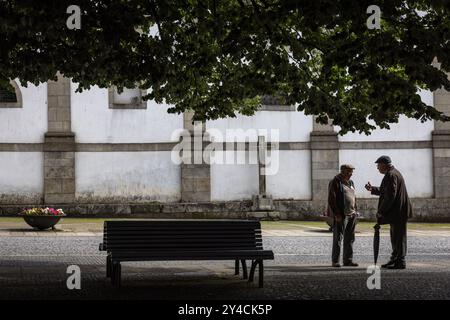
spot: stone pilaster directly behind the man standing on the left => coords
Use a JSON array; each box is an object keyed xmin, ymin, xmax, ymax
[{"xmin": 310, "ymin": 117, "xmax": 339, "ymax": 200}]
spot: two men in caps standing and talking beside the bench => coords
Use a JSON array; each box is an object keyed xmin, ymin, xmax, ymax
[{"xmin": 327, "ymin": 156, "xmax": 412, "ymax": 269}]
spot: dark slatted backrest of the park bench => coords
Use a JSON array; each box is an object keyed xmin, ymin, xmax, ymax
[{"xmin": 103, "ymin": 220, "xmax": 262, "ymax": 251}]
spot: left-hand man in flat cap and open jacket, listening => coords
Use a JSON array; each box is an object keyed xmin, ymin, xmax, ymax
[{"xmin": 327, "ymin": 164, "xmax": 358, "ymax": 267}]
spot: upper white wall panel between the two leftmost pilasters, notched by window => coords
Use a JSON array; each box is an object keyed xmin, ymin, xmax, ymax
[{"xmin": 71, "ymin": 83, "xmax": 183, "ymax": 143}]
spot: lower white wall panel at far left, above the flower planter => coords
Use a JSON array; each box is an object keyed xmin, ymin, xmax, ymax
[{"xmin": 0, "ymin": 152, "xmax": 44, "ymax": 203}]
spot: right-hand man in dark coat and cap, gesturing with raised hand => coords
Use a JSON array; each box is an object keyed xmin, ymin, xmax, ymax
[{"xmin": 365, "ymin": 156, "xmax": 412, "ymax": 269}]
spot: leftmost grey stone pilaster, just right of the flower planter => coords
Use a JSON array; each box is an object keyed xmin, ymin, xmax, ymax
[{"xmin": 44, "ymin": 73, "xmax": 75, "ymax": 205}]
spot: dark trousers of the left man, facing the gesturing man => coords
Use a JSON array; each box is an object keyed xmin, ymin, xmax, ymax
[{"xmin": 331, "ymin": 216, "xmax": 356, "ymax": 264}]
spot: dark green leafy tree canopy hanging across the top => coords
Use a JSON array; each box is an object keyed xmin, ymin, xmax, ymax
[{"xmin": 0, "ymin": 0, "xmax": 450, "ymax": 133}]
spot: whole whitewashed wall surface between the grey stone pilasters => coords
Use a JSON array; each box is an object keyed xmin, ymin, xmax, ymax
[{"xmin": 0, "ymin": 83, "xmax": 442, "ymax": 202}]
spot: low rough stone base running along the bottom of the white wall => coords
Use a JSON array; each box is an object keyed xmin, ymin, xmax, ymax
[{"xmin": 0, "ymin": 199, "xmax": 450, "ymax": 222}]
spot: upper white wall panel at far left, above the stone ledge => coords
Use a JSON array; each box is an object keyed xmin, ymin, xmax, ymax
[{"xmin": 0, "ymin": 81, "xmax": 47, "ymax": 143}]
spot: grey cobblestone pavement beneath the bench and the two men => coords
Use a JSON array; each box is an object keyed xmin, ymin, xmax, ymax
[{"xmin": 0, "ymin": 232, "xmax": 450, "ymax": 300}]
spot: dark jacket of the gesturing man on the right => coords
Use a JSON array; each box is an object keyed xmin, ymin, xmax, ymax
[{"xmin": 371, "ymin": 166, "xmax": 412, "ymax": 224}]
